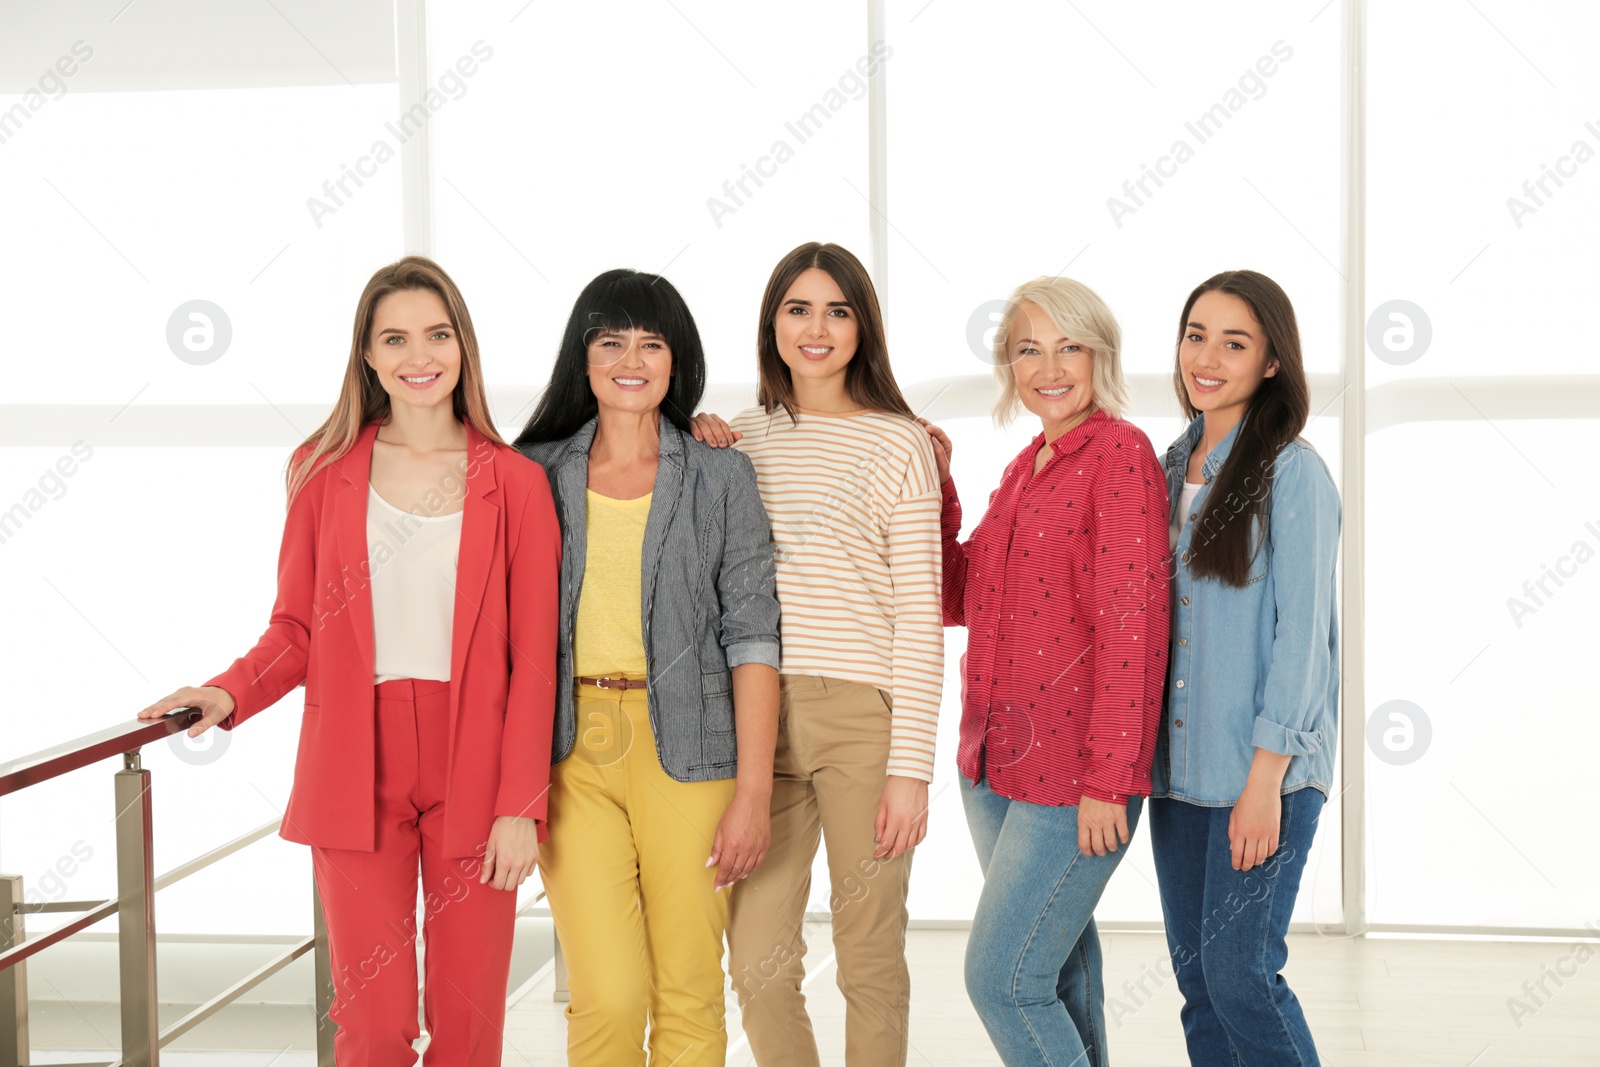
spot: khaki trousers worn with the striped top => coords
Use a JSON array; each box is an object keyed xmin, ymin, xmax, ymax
[{"xmin": 728, "ymin": 675, "xmax": 912, "ymax": 1067}]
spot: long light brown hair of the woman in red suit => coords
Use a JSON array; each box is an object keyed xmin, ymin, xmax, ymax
[{"xmin": 283, "ymin": 256, "xmax": 506, "ymax": 502}]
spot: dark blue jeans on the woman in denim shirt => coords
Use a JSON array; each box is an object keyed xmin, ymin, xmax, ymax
[{"xmin": 1150, "ymin": 787, "xmax": 1323, "ymax": 1067}]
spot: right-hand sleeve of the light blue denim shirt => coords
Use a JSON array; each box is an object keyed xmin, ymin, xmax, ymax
[{"xmin": 1251, "ymin": 448, "xmax": 1341, "ymax": 755}]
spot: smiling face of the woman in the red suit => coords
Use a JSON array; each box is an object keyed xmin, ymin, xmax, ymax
[{"xmin": 365, "ymin": 290, "xmax": 461, "ymax": 408}]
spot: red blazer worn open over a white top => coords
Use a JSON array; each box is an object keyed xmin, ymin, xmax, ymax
[{"xmin": 205, "ymin": 422, "xmax": 562, "ymax": 857}]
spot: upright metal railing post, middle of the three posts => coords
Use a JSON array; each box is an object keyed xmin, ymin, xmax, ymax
[{"xmin": 114, "ymin": 752, "xmax": 162, "ymax": 1067}]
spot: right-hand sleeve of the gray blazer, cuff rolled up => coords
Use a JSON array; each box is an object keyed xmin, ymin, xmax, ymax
[{"xmin": 717, "ymin": 450, "xmax": 781, "ymax": 670}]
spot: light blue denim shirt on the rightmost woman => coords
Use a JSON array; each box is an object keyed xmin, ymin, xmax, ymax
[{"xmin": 1150, "ymin": 416, "xmax": 1339, "ymax": 808}]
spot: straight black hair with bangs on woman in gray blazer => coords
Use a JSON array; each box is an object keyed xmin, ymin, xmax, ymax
[{"xmin": 515, "ymin": 267, "xmax": 706, "ymax": 446}]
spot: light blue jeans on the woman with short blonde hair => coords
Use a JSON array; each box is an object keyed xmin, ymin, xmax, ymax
[{"xmin": 962, "ymin": 777, "xmax": 1142, "ymax": 1067}]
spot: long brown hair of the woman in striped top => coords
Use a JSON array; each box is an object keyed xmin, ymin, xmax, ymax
[{"xmin": 755, "ymin": 242, "xmax": 915, "ymax": 422}]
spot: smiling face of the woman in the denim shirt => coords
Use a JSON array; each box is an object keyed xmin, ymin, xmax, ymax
[{"xmin": 1178, "ymin": 290, "xmax": 1278, "ymax": 429}]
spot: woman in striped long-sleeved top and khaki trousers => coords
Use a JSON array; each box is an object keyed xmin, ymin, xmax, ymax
[{"xmin": 696, "ymin": 243, "xmax": 944, "ymax": 1067}]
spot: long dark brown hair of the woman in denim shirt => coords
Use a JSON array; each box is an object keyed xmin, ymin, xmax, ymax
[{"xmin": 1173, "ymin": 270, "xmax": 1310, "ymax": 585}]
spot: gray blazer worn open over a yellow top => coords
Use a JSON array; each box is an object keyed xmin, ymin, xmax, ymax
[{"xmin": 522, "ymin": 418, "xmax": 779, "ymax": 782}]
